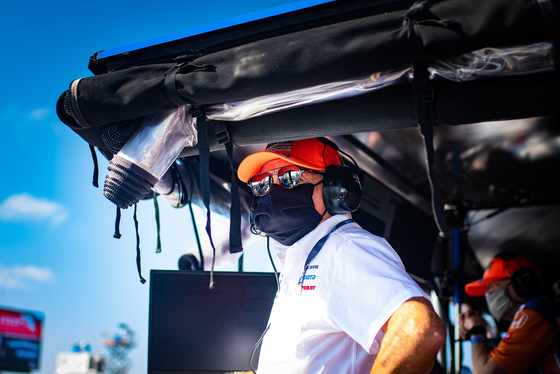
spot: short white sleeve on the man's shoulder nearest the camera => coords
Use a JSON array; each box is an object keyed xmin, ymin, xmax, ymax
[{"xmin": 327, "ymin": 231, "xmax": 426, "ymax": 354}]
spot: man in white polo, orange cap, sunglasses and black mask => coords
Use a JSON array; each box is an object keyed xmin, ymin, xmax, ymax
[{"xmin": 238, "ymin": 138, "xmax": 446, "ymax": 374}]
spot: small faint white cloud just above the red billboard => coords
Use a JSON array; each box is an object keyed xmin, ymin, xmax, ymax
[{"xmin": 0, "ymin": 264, "xmax": 54, "ymax": 289}]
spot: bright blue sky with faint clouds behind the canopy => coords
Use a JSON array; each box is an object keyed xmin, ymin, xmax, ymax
[{"xmin": 0, "ymin": 0, "xmax": 298, "ymax": 374}]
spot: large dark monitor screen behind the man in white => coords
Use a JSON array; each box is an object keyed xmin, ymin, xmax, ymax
[{"xmin": 148, "ymin": 270, "xmax": 277, "ymax": 374}]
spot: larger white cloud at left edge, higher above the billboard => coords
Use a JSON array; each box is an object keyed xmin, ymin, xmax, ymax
[{"xmin": 0, "ymin": 193, "xmax": 68, "ymax": 224}]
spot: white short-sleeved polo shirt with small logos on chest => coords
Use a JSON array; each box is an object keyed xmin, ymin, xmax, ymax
[{"xmin": 258, "ymin": 214, "xmax": 426, "ymax": 374}]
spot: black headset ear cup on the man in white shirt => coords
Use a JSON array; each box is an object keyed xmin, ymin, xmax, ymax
[{"xmin": 323, "ymin": 165, "xmax": 362, "ymax": 214}]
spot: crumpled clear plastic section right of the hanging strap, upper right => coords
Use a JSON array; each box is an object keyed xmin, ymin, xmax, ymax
[{"xmin": 428, "ymin": 42, "xmax": 554, "ymax": 82}]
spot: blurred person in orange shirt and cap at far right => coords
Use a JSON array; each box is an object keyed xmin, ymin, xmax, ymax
[{"xmin": 459, "ymin": 252, "xmax": 560, "ymax": 374}]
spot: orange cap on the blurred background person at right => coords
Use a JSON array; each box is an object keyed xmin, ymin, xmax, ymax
[{"xmin": 465, "ymin": 255, "xmax": 537, "ymax": 296}]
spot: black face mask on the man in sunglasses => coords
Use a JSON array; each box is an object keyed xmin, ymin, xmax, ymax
[{"xmin": 253, "ymin": 183, "xmax": 323, "ymax": 245}]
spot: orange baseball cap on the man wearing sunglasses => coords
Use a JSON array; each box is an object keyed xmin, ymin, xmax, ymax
[{"xmin": 237, "ymin": 138, "xmax": 340, "ymax": 182}]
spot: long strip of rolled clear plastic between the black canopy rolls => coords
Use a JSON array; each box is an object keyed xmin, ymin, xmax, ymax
[{"xmin": 206, "ymin": 42, "xmax": 554, "ymax": 121}]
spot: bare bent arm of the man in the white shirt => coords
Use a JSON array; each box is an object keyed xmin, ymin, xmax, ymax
[{"xmin": 371, "ymin": 297, "xmax": 446, "ymax": 373}]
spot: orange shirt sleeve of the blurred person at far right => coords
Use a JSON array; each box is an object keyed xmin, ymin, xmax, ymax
[{"xmin": 490, "ymin": 309, "xmax": 555, "ymax": 374}]
